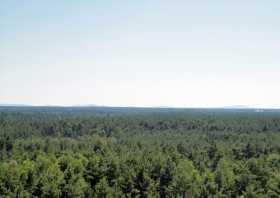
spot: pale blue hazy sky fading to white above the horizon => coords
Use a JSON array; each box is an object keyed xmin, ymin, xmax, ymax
[{"xmin": 0, "ymin": 0, "xmax": 280, "ymax": 108}]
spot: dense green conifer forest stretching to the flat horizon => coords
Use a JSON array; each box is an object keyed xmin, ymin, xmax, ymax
[{"xmin": 0, "ymin": 107, "xmax": 280, "ymax": 198}]
